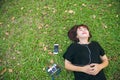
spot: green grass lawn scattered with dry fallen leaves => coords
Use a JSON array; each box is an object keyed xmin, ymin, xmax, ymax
[{"xmin": 0, "ymin": 0, "xmax": 120, "ymax": 80}]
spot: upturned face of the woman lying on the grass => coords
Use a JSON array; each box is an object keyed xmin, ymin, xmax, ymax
[{"xmin": 77, "ymin": 26, "xmax": 90, "ymax": 38}]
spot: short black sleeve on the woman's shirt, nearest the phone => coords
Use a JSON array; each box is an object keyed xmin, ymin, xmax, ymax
[{"xmin": 63, "ymin": 44, "xmax": 74, "ymax": 62}]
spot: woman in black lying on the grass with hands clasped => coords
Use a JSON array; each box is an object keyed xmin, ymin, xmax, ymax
[{"xmin": 63, "ymin": 24, "xmax": 108, "ymax": 80}]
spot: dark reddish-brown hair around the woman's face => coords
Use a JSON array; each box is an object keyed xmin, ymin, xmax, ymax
[{"xmin": 68, "ymin": 24, "xmax": 92, "ymax": 42}]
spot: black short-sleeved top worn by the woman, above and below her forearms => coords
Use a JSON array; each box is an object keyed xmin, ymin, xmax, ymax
[{"xmin": 63, "ymin": 41, "xmax": 106, "ymax": 80}]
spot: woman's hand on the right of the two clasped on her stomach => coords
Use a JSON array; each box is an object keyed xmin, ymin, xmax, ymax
[{"xmin": 90, "ymin": 63, "xmax": 102, "ymax": 75}]
